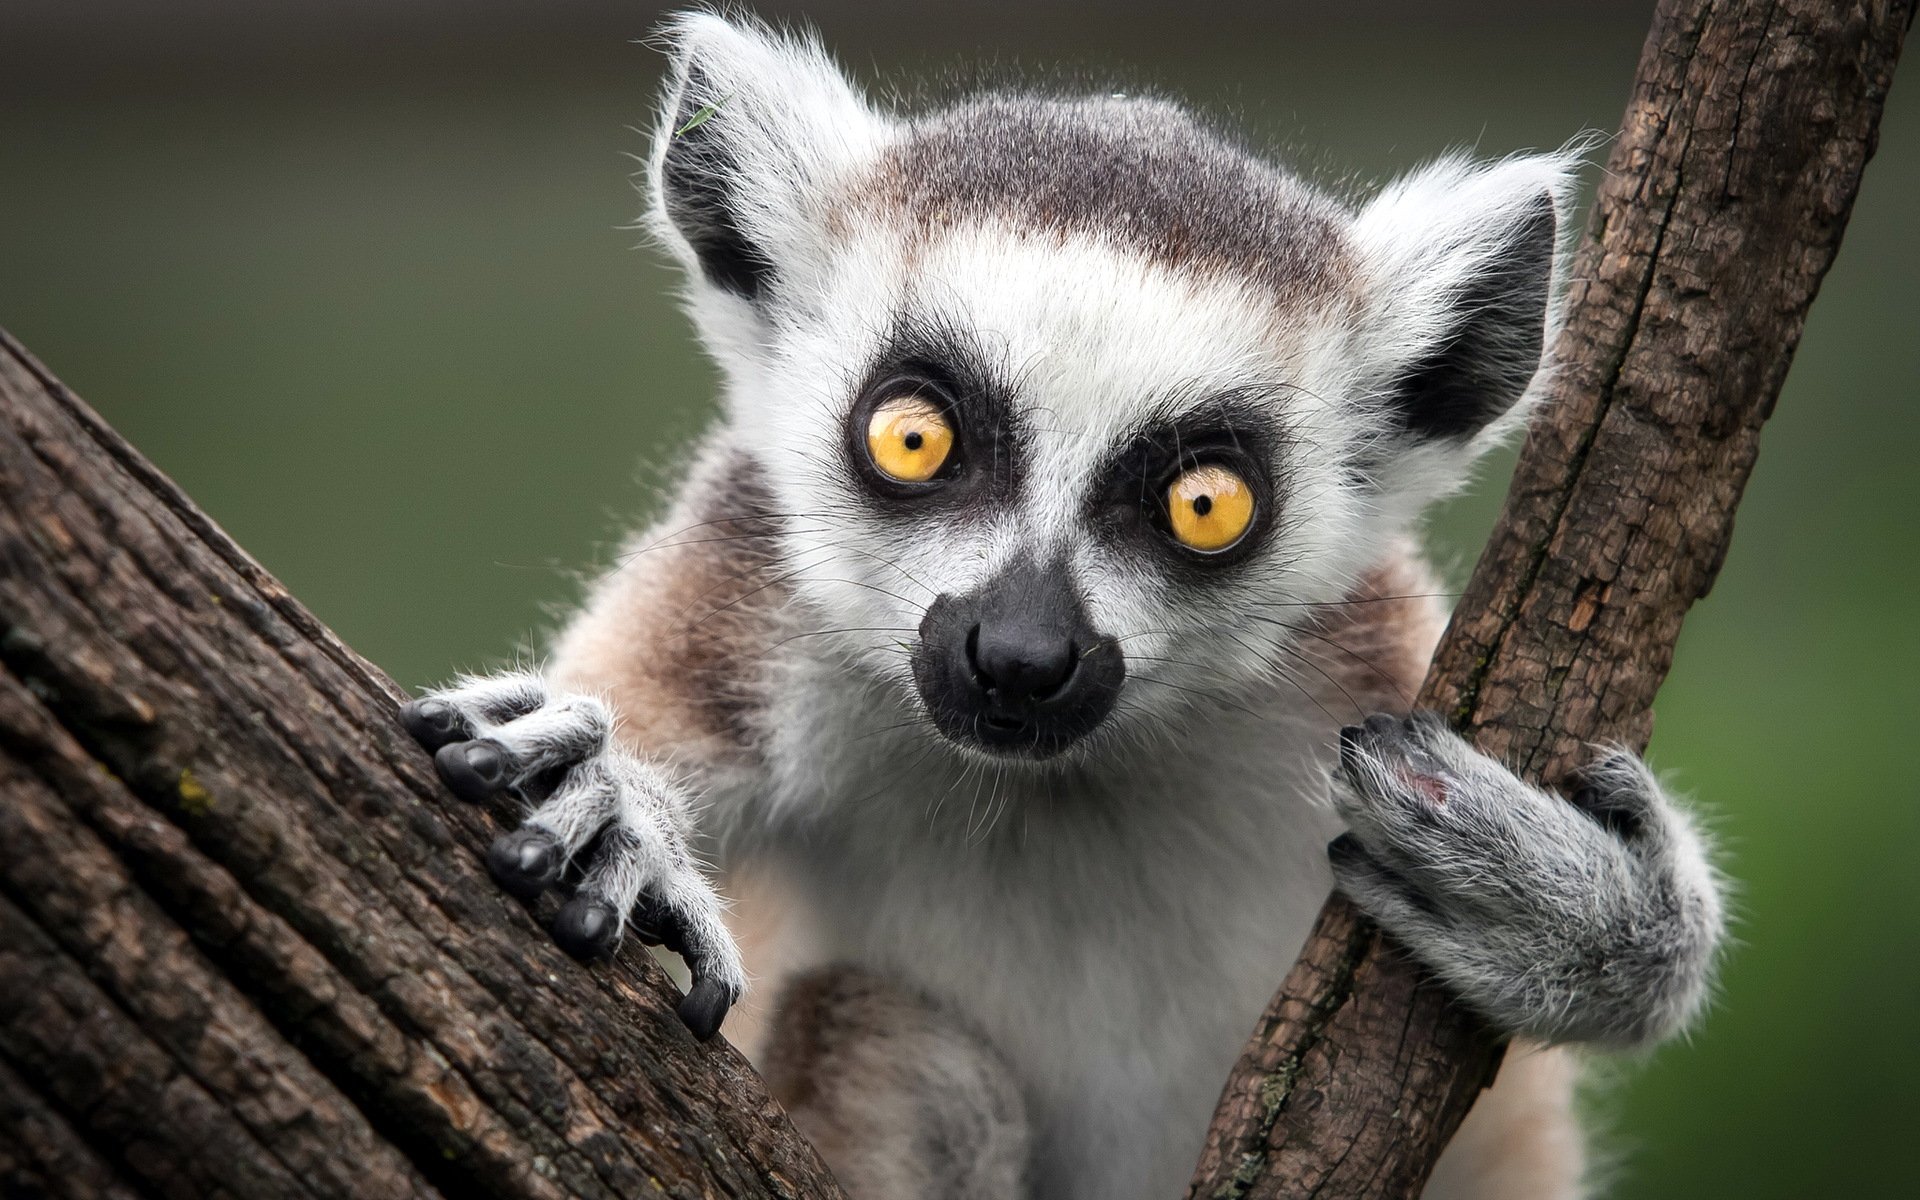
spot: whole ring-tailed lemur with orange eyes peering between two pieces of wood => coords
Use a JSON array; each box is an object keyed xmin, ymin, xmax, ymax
[{"xmin": 403, "ymin": 13, "xmax": 1722, "ymax": 1200}]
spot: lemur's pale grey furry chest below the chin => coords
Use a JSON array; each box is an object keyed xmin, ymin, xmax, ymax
[{"xmin": 756, "ymin": 739, "xmax": 1336, "ymax": 1196}]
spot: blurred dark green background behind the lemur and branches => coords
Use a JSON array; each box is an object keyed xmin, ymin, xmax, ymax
[{"xmin": 0, "ymin": 0, "xmax": 1920, "ymax": 1198}]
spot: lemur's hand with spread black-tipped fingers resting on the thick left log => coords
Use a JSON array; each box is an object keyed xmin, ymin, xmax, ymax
[{"xmin": 399, "ymin": 672, "xmax": 747, "ymax": 1041}]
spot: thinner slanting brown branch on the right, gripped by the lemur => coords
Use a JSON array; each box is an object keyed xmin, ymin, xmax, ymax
[{"xmin": 1188, "ymin": 0, "xmax": 1914, "ymax": 1200}]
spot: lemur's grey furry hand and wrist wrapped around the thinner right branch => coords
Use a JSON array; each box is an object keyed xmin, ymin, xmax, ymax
[{"xmin": 1329, "ymin": 712, "xmax": 1722, "ymax": 1046}]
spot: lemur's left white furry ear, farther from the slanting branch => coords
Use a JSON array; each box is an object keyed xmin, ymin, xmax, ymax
[{"xmin": 649, "ymin": 13, "xmax": 885, "ymax": 301}]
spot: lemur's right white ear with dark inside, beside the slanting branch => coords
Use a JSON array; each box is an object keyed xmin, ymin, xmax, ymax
[{"xmin": 1354, "ymin": 152, "xmax": 1578, "ymax": 449}]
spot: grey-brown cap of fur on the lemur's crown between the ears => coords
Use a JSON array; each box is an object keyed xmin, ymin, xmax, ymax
[{"xmin": 874, "ymin": 94, "xmax": 1346, "ymax": 296}]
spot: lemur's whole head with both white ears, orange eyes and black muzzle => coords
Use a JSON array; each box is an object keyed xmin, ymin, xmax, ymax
[{"xmin": 651, "ymin": 15, "xmax": 1572, "ymax": 758}]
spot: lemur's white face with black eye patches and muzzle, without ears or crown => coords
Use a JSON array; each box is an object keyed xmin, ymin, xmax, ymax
[{"xmin": 802, "ymin": 224, "xmax": 1344, "ymax": 756}]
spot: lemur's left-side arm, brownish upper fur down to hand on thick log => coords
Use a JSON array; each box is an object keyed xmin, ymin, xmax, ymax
[{"xmin": 405, "ymin": 442, "xmax": 785, "ymax": 1037}]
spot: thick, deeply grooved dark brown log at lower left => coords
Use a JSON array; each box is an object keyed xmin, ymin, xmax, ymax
[{"xmin": 0, "ymin": 322, "xmax": 839, "ymax": 1200}]
